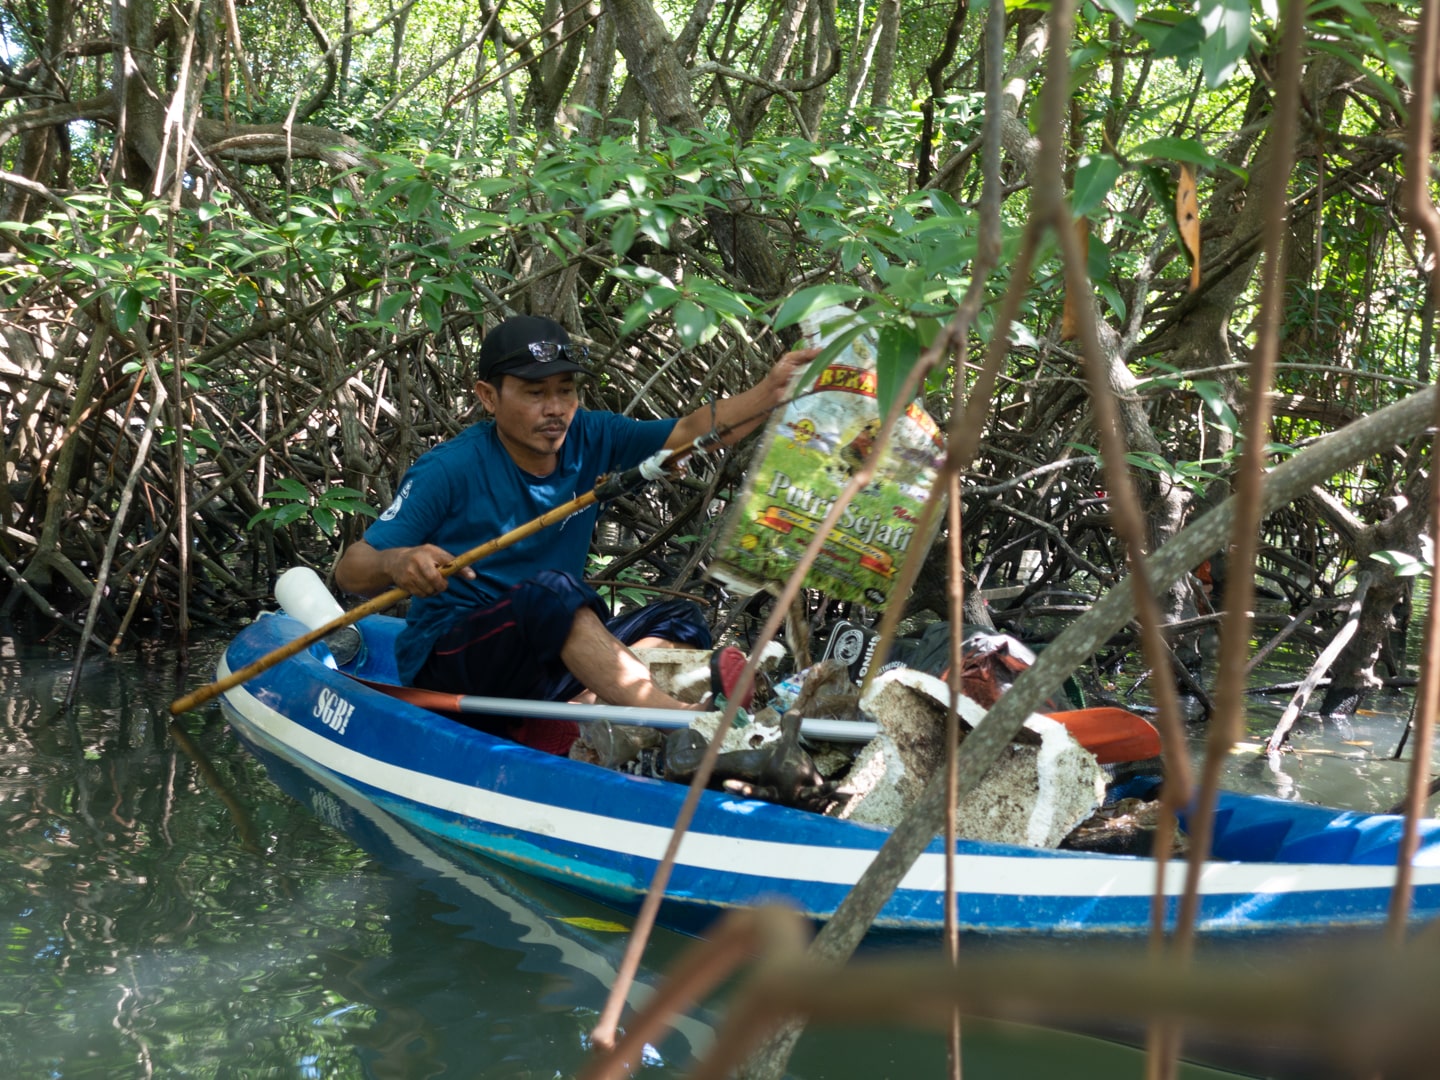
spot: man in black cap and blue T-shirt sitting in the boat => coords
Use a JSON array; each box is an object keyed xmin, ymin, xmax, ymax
[{"xmin": 336, "ymin": 315, "xmax": 816, "ymax": 753}]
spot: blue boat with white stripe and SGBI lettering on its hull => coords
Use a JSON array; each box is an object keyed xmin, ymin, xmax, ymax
[{"xmin": 219, "ymin": 615, "xmax": 1440, "ymax": 937}]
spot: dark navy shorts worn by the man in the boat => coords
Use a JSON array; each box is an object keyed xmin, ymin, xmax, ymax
[{"xmin": 415, "ymin": 570, "xmax": 711, "ymax": 701}]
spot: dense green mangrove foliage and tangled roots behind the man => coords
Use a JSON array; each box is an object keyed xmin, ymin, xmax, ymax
[{"xmin": 0, "ymin": 0, "xmax": 1434, "ymax": 702}]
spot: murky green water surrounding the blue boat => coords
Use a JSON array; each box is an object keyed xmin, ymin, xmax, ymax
[{"xmin": 0, "ymin": 628, "xmax": 1428, "ymax": 1080}]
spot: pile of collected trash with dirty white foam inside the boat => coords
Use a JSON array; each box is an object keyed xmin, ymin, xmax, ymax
[{"xmin": 570, "ymin": 624, "xmax": 1182, "ymax": 854}]
